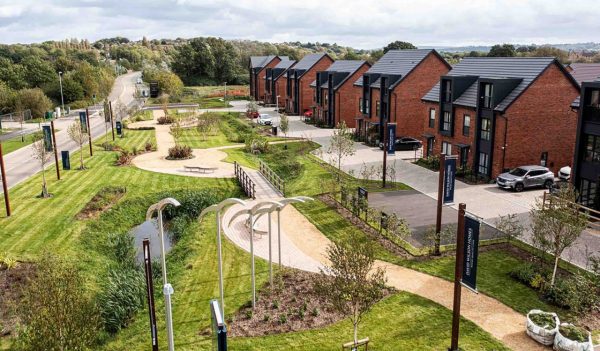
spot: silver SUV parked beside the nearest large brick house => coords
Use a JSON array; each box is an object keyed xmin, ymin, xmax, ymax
[{"xmin": 496, "ymin": 166, "xmax": 554, "ymax": 191}]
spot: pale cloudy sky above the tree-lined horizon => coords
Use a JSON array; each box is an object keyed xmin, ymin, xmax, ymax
[{"xmin": 0, "ymin": 0, "xmax": 600, "ymax": 49}]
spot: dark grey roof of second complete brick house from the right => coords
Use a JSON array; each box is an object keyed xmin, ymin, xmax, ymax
[{"xmin": 354, "ymin": 49, "xmax": 435, "ymax": 87}]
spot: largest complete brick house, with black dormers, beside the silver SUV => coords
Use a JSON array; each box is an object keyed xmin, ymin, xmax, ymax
[{"xmin": 422, "ymin": 57, "xmax": 579, "ymax": 178}]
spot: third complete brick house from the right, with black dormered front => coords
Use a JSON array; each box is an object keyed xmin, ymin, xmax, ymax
[{"xmin": 310, "ymin": 60, "xmax": 371, "ymax": 128}]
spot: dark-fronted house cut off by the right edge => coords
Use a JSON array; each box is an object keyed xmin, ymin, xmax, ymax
[{"xmin": 571, "ymin": 76, "xmax": 600, "ymax": 210}]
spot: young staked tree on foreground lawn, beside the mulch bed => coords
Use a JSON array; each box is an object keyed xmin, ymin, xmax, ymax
[{"xmin": 316, "ymin": 238, "xmax": 386, "ymax": 344}]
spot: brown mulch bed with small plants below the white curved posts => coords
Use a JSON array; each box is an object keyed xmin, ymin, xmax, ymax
[{"xmin": 227, "ymin": 269, "xmax": 391, "ymax": 337}]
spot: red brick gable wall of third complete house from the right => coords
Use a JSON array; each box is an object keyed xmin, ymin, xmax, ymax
[{"xmin": 334, "ymin": 63, "xmax": 371, "ymax": 128}]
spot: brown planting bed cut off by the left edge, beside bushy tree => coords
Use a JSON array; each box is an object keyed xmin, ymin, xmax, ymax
[{"xmin": 0, "ymin": 262, "xmax": 35, "ymax": 337}]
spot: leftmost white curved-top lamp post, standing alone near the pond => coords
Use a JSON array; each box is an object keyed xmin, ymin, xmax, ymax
[{"xmin": 146, "ymin": 197, "xmax": 181, "ymax": 351}]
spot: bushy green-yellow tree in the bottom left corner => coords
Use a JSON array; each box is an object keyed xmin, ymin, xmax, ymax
[{"xmin": 17, "ymin": 253, "xmax": 100, "ymax": 351}]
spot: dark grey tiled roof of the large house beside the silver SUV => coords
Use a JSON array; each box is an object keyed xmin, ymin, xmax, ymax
[{"xmin": 423, "ymin": 57, "xmax": 562, "ymax": 111}]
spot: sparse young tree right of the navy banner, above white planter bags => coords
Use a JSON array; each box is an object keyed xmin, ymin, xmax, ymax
[{"xmin": 530, "ymin": 187, "xmax": 587, "ymax": 286}]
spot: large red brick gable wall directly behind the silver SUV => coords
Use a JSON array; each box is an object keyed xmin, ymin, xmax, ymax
[{"xmin": 493, "ymin": 64, "xmax": 579, "ymax": 174}]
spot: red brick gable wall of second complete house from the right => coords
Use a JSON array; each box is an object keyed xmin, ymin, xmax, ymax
[{"xmin": 390, "ymin": 53, "xmax": 448, "ymax": 138}]
